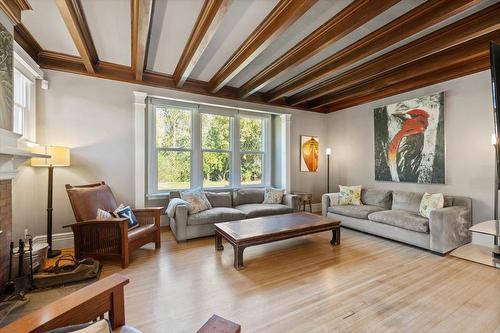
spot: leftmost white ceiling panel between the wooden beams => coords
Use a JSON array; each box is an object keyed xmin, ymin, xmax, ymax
[{"xmin": 21, "ymin": 0, "xmax": 79, "ymax": 56}]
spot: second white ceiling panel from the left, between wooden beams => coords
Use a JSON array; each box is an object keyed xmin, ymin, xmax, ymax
[{"xmin": 81, "ymin": 0, "xmax": 131, "ymax": 66}]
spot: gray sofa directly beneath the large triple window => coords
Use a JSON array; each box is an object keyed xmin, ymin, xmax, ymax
[{"xmin": 170, "ymin": 188, "xmax": 299, "ymax": 241}]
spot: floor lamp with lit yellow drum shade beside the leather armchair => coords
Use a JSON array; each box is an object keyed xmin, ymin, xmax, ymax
[{"xmin": 31, "ymin": 146, "xmax": 70, "ymax": 258}]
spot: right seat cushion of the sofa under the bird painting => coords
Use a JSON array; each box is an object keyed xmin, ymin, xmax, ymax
[{"xmin": 368, "ymin": 210, "xmax": 429, "ymax": 233}]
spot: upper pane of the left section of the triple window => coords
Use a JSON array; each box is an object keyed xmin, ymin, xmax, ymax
[{"xmin": 156, "ymin": 107, "xmax": 191, "ymax": 149}]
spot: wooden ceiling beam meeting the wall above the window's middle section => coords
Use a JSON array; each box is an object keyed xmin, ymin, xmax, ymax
[{"xmin": 209, "ymin": 0, "xmax": 317, "ymax": 93}]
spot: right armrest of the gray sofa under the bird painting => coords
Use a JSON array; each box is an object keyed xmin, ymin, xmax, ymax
[{"xmin": 429, "ymin": 206, "xmax": 472, "ymax": 254}]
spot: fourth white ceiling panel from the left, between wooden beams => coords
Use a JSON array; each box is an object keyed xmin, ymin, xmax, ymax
[{"xmin": 191, "ymin": 0, "xmax": 278, "ymax": 81}]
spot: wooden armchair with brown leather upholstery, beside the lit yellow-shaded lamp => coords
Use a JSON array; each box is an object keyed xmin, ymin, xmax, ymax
[{"xmin": 65, "ymin": 182, "xmax": 163, "ymax": 268}]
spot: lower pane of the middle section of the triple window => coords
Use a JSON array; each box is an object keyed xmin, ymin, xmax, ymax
[{"xmin": 203, "ymin": 152, "xmax": 230, "ymax": 187}]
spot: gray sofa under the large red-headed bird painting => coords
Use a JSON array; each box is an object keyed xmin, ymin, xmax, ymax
[{"xmin": 322, "ymin": 189, "xmax": 472, "ymax": 254}]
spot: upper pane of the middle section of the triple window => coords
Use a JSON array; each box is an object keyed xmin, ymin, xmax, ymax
[{"xmin": 201, "ymin": 113, "xmax": 230, "ymax": 150}]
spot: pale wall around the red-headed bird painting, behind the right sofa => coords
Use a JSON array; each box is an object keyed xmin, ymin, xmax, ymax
[{"xmin": 327, "ymin": 71, "xmax": 495, "ymax": 235}]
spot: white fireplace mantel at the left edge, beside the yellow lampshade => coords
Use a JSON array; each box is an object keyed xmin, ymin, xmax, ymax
[{"xmin": 0, "ymin": 128, "xmax": 50, "ymax": 180}]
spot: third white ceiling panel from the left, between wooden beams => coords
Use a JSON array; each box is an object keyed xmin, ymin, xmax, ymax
[{"xmin": 147, "ymin": 0, "xmax": 203, "ymax": 74}]
